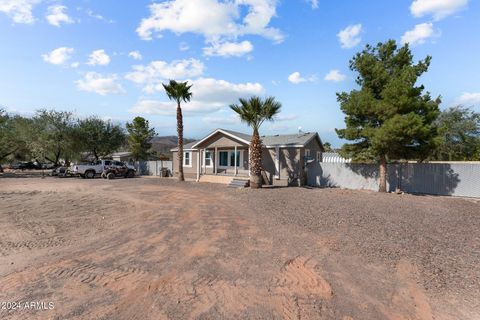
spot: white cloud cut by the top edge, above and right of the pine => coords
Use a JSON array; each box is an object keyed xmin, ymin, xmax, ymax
[{"xmin": 410, "ymin": 0, "xmax": 468, "ymax": 20}]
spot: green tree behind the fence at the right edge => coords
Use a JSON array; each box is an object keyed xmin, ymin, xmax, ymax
[{"xmin": 432, "ymin": 106, "xmax": 480, "ymax": 161}]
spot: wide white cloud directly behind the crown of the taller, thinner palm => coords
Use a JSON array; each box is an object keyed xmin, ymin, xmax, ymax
[{"xmin": 130, "ymin": 78, "xmax": 265, "ymax": 115}]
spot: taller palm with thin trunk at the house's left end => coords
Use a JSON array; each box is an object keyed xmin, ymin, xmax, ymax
[{"xmin": 162, "ymin": 80, "xmax": 192, "ymax": 181}]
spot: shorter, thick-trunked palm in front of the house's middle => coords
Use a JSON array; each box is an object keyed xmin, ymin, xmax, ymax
[{"xmin": 230, "ymin": 97, "xmax": 282, "ymax": 188}]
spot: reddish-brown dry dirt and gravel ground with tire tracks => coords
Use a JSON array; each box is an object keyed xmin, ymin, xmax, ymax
[{"xmin": 0, "ymin": 178, "xmax": 480, "ymax": 320}]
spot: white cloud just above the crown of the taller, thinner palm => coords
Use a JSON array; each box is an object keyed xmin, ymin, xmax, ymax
[{"xmin": 125, "ymin": 59, "xmax": 205, "ymax": 93}]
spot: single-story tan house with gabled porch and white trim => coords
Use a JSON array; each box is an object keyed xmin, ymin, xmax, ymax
[{"xmin": 171, "ymin": 129, "xmax": 324, "ymax": 186}]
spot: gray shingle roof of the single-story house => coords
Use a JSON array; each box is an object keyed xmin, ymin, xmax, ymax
[{"xmin": 172, "ymin": 129, "xmax": 317, "ymax": 151}]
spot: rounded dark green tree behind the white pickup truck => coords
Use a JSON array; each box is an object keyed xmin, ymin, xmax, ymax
[{"xmin": 76, "ymin": 117, "xmax": 125, "ymax": 160}]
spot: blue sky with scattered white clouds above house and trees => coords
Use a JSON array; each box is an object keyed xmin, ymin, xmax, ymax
[{"xmin": 0, "ymin": 0, "xmax": 480, "ymax": 146}]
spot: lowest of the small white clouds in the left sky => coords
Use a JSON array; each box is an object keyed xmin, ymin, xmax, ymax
[{"xmin": 76, "ymin": 72, "xmax": 125, "ymax": 96}]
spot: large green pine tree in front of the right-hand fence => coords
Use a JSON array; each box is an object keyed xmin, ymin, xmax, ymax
[{"xmin": 336, "ymin": 40, "xmax": 440, "ymax": 192}]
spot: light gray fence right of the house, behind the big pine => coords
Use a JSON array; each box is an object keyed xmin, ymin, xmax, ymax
[{"xmin": 307, "ymin": 162, "xmax": 480, "ymax": 197}]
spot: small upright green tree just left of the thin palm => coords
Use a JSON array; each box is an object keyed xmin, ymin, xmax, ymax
[{"xmin": 127, "ymin": 117, "xmax": 155, "ymax": 161}]
